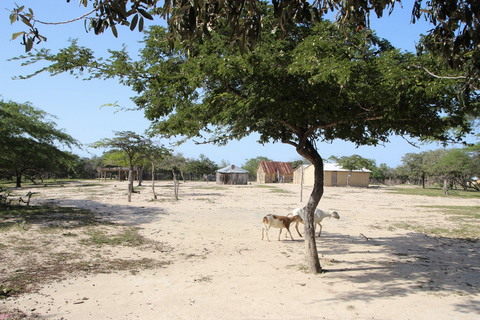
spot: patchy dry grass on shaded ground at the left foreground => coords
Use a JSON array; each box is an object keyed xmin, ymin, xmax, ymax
[{"xmin": 0, "ymin": 206, "xmax": 170, "ymax": 297}]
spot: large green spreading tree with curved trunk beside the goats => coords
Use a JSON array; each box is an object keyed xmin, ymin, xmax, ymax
[{"xmin": 8, "ymin": 7, "xmax": 477, "ymax": 272}]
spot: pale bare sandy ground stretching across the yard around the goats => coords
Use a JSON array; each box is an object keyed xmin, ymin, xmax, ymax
[{"xmin": 0, "ymin": 181, "xmax": 480, "ymax": 320}]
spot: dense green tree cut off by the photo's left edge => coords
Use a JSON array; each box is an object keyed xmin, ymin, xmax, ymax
[{"xmin": 0, "ymin": 99, "xmax": 80, "ymax": 187}]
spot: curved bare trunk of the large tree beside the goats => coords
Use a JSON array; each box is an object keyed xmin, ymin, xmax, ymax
[{"xmin": 297, "ymin": 140, "xmax": 324, "ymax": 273}]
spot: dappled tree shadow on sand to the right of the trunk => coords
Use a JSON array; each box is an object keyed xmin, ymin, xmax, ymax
[{"xmin": 317, "ymin": 233, "xmax": 480, "ymax": 314}]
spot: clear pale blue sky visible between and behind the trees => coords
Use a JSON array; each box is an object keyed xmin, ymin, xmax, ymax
[{"xmin": 0, "ymin": 0, "xmax": 472, "ymax": 167}]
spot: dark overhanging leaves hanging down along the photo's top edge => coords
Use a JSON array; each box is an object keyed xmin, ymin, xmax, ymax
[{"xmin": 10, "ymin": 0, "xmax": 480, "ymax": 86}]
